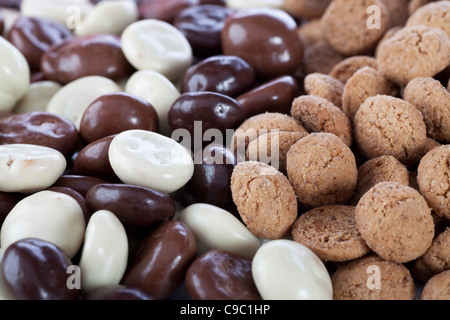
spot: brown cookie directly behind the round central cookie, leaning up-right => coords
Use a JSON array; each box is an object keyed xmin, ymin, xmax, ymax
[{"xmin": 291, "ymin": 95, "xmax": 353, "ymax": 147}]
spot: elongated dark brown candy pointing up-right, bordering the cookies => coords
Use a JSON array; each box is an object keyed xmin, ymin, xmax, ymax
[{"xmin": 236, "ymin": 76, "xmax": 298, "ymax": 117}]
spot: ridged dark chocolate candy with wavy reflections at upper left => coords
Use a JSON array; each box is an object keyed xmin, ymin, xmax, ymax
[{"xmin": 7, "ymin": 16, "xmax": 73, "ymax": 70}]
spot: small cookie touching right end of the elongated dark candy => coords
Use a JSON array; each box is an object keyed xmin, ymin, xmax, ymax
[{"xmin": 304, "ymin": 73, "xmax": 344, "ymax": 108}]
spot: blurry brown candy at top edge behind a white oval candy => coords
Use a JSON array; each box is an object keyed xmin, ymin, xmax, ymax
[{"xmin": 138, "ymin": 0, "xmax": 200, "ymax": 23}]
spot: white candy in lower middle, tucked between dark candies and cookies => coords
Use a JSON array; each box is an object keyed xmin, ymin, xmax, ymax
[{"xmin": 178, "ymin": 203, "xmax": 261, "ymax": 259}]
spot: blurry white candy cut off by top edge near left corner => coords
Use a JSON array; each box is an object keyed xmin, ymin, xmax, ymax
[{"xmin": 20, "ymin": 0, "xmax": 93, "ymax": 30}]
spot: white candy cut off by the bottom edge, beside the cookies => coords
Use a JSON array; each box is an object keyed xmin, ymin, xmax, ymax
[{"xmin": 252, "ymin": 240, "xmax": 333, "ymax": 300}]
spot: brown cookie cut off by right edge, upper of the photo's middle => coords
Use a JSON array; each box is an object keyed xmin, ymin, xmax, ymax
[{"xmin": 403, "ymin": 77, "xmax": 450, "ymax": 143}]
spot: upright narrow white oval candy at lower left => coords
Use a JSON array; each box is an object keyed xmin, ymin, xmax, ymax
[{"xmin": 79, "ymin": 210, "xmax": 128, "ymax": 293}]
